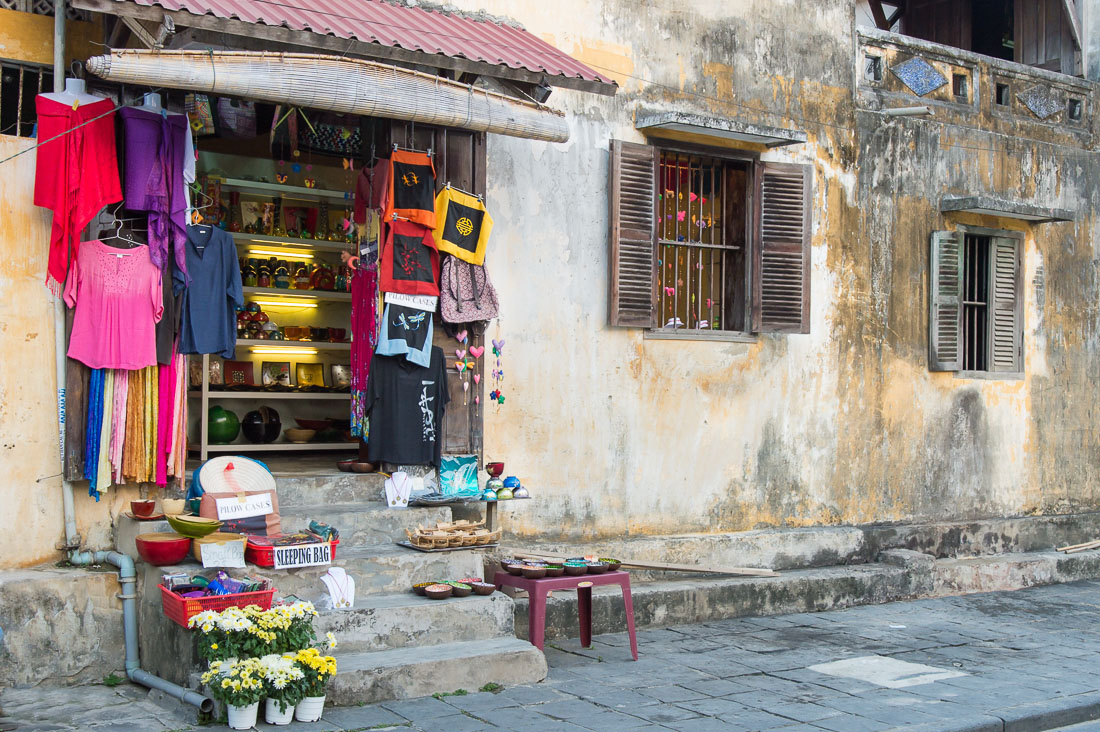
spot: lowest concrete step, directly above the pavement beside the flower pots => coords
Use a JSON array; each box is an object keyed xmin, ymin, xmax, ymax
[{"xmin": 328, "ymin": 637, "xmax": 547, "ymax": 706}]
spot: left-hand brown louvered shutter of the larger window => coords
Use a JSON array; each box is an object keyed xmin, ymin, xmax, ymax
[{"xmin": 607, "ymin": 140, "xmax": 658, "ymax": 328}]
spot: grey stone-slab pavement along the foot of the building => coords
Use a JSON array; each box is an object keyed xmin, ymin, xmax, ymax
[{"xmin": 0, "ymin": 581, "xmax": 1100, "ymax": 732}]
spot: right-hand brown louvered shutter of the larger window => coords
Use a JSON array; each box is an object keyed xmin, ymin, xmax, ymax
[{"xmin": 752, "ymin": 163, "xmax": 813, "ymax": 332}]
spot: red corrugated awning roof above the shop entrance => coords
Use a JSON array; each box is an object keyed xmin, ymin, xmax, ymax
[{"xmin": 73, "ymin": 0, "xmax": 617, "ymax": 95}]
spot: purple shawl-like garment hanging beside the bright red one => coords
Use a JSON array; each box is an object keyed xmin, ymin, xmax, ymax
[{"xmin": 119, "ymin": 107, "xmax": 189, "ymax": 281}]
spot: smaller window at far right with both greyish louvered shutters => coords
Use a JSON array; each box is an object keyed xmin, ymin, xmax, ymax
[{"xmin": 928, "ymin": 229, "xmax": 1023, "ymax": 373}]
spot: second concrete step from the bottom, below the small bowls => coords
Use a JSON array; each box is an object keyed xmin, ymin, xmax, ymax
[{"xmin": 314, "ymin": 592, "xmax": 515, "ymax": 657}]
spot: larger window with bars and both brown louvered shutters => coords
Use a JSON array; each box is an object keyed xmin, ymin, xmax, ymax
[{"xmin": 608, "ymin": 140, "xmax": 811, "ymax": 336}]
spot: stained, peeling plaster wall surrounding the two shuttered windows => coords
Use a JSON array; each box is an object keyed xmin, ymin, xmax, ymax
[{"xmin": 444, "ymin": 0, "xmax": 1100, "ymax": 538}]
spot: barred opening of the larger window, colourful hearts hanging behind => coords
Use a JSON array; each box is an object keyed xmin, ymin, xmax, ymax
[{"xmin": 655, "ymin": 152, "xmax": 739, "ymax": 330}]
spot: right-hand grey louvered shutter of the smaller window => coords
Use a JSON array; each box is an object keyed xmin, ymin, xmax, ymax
[{"xmin": 989, "ymin": 237, "xmax": 1023, "ymax": 373}]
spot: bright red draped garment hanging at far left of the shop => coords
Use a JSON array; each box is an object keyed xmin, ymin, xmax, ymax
[{"xmin": 34, "ymin": 95, "xmax": 122, "ymax": 294}]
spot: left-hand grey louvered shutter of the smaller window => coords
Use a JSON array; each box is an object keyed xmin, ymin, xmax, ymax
[{"xmin": 928, "ymin": 231, "xmax": 963, "ymax": 371}]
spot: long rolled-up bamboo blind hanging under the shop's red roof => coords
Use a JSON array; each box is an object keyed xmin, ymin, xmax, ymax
[{"xmin": 87, "ymin": 50, "xmax": 569, "ymax": 142}]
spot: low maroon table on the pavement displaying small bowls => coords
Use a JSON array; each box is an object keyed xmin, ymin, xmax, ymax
[{"xmin": 493, "ymin": 570, "xmax": 638, "ymax": 660}]
